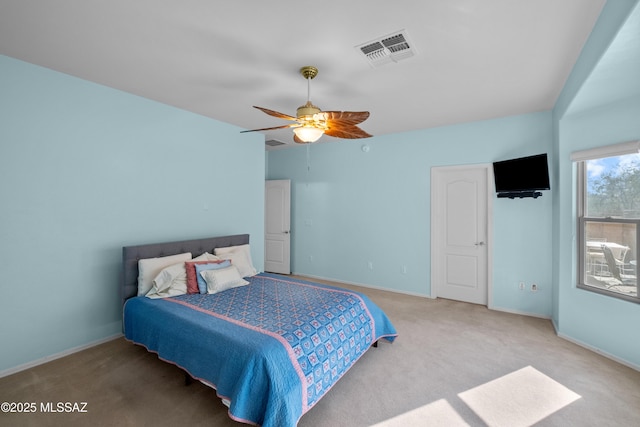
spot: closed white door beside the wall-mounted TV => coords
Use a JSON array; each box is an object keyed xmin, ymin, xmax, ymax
[{"xmin": 431, "ymin": 165, "xmax": 491, "ymax": 305}]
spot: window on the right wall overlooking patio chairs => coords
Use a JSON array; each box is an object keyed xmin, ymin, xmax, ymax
[{"xmin": 572, "ymin": 142, "xmax": 640, "ymax": 303}]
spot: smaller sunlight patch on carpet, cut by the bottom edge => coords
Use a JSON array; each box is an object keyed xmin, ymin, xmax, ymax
[{"xmin": 371, "ymin": 399, "xmax": 469, "ymax": 427}]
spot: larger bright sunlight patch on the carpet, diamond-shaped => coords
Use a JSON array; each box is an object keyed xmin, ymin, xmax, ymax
[{"xmin": 458, "ymin": 366, "xmax": 580, "ymax": 427}]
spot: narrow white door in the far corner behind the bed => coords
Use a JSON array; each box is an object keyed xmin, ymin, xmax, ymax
[{"xmin": 264, "ymin": 179, "xmax": 291, "ymax": 274}]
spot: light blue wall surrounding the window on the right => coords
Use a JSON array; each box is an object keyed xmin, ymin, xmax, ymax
[{"xmin": 553, "ymin": 0, "xmax": 640, "ymax": 369}]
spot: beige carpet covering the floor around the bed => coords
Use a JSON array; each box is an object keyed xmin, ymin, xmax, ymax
[{"xmin": 0, "ymin": 285, "xmax": 640, "ymax": 427}]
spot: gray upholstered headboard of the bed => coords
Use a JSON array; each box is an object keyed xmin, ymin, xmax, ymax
[{"xmin": 120, "ymin": 234, "xmax": 249, "ymax": 304}]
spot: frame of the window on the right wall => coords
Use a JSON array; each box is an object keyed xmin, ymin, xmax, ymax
[{"xmin": 571, "ymin": 141, "xmax": 640, "ymax": 304}]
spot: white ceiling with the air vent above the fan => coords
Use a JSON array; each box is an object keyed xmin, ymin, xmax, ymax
[{"xmin": 0, "ymin": 0, "xmax": 605, "ymax": 150}]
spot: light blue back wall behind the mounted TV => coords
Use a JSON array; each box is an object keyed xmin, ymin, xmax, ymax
[{"xmin": 267, "ymin": 112, "xmax": 553, "ymax": 317}]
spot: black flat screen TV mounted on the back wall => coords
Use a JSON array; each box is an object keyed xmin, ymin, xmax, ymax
[{"xmin": 493, "ymin": 153, "xmax": 551, "ymax": 197}]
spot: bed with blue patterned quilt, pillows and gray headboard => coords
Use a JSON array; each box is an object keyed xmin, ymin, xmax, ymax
[{"xmin": 121, "ymin": 234, "xmax": 397, "ymax": 427}]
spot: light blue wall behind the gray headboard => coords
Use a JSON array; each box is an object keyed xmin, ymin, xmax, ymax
[{"xmin": 0, "ymin": 56, "xmax": 265, "ymax": 371}]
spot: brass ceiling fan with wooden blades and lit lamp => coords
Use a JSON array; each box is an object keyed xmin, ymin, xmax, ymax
[{"xmin": 242, "ymin": 66, "xmax": 371, "ymax": 144}]
